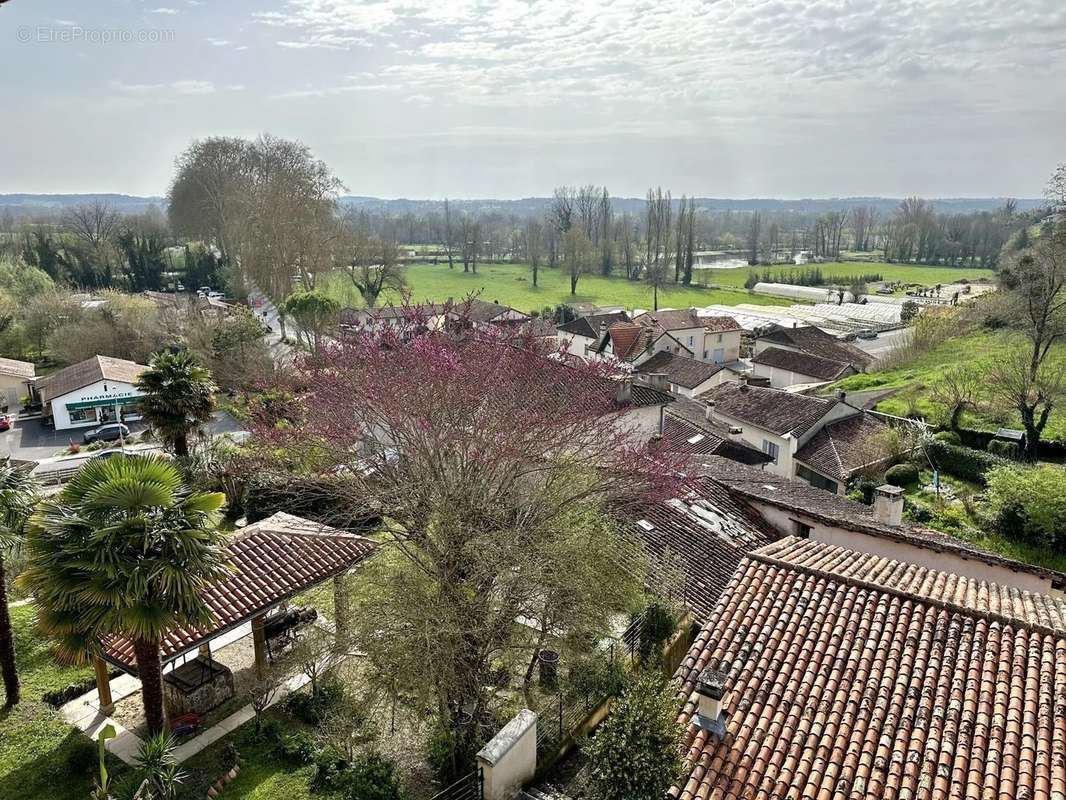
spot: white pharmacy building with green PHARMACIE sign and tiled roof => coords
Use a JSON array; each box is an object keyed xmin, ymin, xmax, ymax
[{"xmin": 37, "ymin": 355, "xmax": 147, "ymax": 431}]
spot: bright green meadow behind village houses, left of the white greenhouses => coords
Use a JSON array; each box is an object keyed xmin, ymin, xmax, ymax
[{"xmin": 315, "ymin": 263, "xmax": 791, "ymax": 311}]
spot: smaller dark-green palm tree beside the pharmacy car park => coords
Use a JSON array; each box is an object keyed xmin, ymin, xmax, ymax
[{"xmin": 136, "ymin": 350, "xmax": 215, "ymax": 455}]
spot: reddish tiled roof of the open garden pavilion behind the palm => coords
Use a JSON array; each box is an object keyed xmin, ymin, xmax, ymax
[{"xmin": 103, "ymin": 512, "xmax": 374, "ymax": 672}]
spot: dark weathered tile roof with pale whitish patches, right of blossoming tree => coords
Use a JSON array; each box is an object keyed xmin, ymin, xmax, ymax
[{"xmin": 624, "ymin": 478, "xmax": 778, "ymax": 622}]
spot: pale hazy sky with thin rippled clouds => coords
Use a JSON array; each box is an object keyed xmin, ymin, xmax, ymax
[{"xmin": 0, "ymin": 0, "xmax": 1066, "ymax": 198}]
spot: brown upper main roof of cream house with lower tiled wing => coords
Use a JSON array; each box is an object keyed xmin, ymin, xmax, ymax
[{"xmin": 699, "ymin": 381, "xmax": 839, "ymax": 436}]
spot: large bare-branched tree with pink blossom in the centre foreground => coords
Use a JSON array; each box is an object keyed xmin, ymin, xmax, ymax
[{"xmin": 249, "ymin": 304, "xmax": 682, "ymax": 769}]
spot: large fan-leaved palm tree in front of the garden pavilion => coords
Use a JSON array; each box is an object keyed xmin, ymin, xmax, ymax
[{"xmin": 19, "ymin": 455, "xmax": 228, "ymax": 733}]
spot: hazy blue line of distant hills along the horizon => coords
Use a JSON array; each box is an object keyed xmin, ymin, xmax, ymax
[{"xmin": 0, "ymin": 194, "xmax": 1046, "ymax": 217}]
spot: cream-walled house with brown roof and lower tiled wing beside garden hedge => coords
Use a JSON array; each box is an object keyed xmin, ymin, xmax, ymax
[{"xmin": 699, "ymin": 380, "xmax": 877, "ymax": 493}]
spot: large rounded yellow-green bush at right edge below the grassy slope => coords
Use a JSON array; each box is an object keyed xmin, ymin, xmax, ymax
[{"xmin": 985, "ymin": 464, "xmax": 1066, "ymax": 549}]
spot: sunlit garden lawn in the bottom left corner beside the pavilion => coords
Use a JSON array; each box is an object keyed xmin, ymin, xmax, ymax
[{"xmin": 0, "ymin": 606, "xmax": 95, "ymax": 800}]
